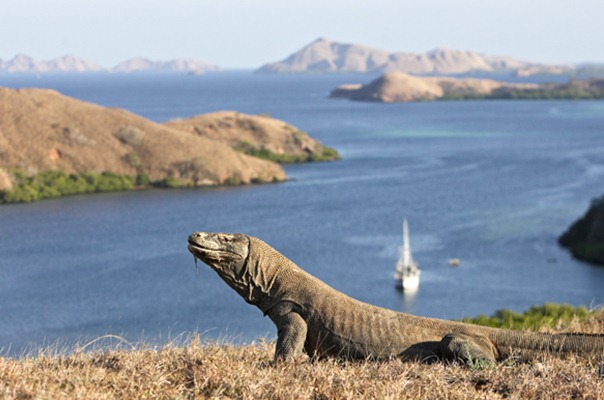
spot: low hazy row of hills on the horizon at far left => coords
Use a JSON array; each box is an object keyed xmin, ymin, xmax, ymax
[{"xmin": 0, "ymin": 54, "xmax": 222, "ymax": 74}]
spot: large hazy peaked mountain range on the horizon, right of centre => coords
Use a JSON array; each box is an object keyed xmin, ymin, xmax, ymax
[{"xmin": 257, "ymin": 38, "xmax": 560, "ymax": 74}]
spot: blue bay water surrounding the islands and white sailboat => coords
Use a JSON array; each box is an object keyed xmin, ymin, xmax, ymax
[{"xmin": 0, "ymin": 73, "xmax": 604, "ymax": 354}]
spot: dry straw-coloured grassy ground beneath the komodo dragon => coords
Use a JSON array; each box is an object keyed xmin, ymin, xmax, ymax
[{"xmin": 0, "ymin": 304, "xmax": 604, "ymax": 399}]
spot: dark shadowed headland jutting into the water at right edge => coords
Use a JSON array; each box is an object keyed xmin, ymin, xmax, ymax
[{"xmin": 558, "ymin": 197, "xmax": 604, "ymax": 265}]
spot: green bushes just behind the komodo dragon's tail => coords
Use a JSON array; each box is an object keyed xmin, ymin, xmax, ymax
[{"xmin": 462, "ymin": 303, "xmax": 598, "ymax": 331}]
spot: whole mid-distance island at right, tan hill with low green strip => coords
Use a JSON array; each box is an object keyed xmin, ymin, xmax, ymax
[{"xmin": 330, "ymin": 72, "xmax": 604, "ymax": 103}]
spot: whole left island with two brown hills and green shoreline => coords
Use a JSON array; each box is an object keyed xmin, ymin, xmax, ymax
[{"xmin": 0, "ymin": 88, "xmax": 339, "ymax": 203}]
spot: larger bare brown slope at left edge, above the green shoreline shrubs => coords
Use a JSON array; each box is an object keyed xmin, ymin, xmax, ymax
[{"xmin": 0, "ymin": 88, "xmax": 285, "ymax": 185}]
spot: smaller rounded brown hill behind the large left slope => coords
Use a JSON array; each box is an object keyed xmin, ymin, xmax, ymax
[{"xmin": 165, "ymin": 111, "xmax": 338, "ymax": 162}]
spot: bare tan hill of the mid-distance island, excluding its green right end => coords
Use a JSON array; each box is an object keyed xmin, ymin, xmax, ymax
[{"xmin": 331, "ymin": 72, "xmax": 535, "ymax": 103}]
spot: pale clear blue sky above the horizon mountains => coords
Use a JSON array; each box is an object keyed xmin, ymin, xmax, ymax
[{"xmin": 0, "ymin": 0, "xmax": 604, "ymax": 68}]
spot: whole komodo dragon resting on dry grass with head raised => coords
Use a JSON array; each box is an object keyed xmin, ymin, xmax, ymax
[{"xmin": 188, "ymin": 232, "xmax": 604, "ymax": 363}]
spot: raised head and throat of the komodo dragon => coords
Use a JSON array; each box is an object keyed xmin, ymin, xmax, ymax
[{"xmin": 188, "ymin": 232, "xmax": 253, "ymax": 302}]
